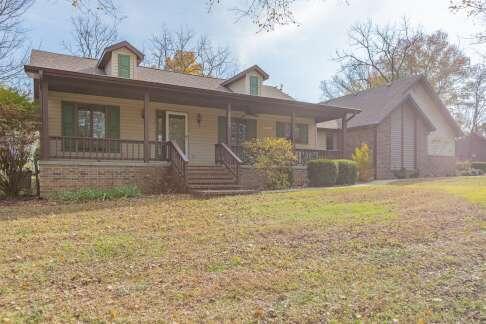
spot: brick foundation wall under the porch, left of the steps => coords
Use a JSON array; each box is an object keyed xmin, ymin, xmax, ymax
[{"xmin": 39, "ymin": 161, "xmax": 170, "ymax": 195}]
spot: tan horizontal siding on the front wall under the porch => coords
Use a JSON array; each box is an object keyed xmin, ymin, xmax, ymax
[{"xmin": 49, "ymin": 92, "xmax": 317, "ymax": 164}]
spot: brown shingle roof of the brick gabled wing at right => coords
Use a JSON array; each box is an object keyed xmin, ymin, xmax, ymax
[{"xmin": 318, "ymin": 75, "xmax": 462, "ymax": 136}]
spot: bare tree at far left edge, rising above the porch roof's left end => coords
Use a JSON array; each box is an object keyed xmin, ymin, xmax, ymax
[{"xmin": 0, "ymin": 0, "xmax": 34, "ymax": 83}]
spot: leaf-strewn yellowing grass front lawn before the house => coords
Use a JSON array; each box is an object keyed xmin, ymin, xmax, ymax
[{"xmin": 0, "ymin": 177, "xmax": 486, "ymax": 323}]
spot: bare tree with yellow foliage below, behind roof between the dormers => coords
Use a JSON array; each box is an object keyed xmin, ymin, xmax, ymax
[{"xmin": 150, "ymin": 27, "xmax": 236, "ymax": 77}]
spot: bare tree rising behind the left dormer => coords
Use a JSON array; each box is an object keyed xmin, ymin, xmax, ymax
[{"xmin": 62, "ymin": 11, "xmax": 122, "ymax": 58}]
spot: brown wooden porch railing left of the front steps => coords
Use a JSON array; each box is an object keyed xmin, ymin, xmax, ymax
[{"xmin": 49, "ymin": 136, "xmax": 167, "ymax": 161}]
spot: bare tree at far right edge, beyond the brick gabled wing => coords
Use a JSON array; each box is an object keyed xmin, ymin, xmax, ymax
[{"xmin": 460, "ymin": 64, "xmax": 486, "ymax": 133}]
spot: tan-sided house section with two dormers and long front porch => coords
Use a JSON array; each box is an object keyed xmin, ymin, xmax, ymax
[{"xmin": 24, "ymin": 42, "xmax": 359, "ymax": 194}]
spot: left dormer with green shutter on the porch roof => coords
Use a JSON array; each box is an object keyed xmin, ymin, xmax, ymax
[{"xmin": 98, "ymin": 41, "xmax": 144, "ymax": 79}]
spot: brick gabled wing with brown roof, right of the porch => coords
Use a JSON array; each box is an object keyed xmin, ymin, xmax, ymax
[{"xmin": 318, "ymin": 76, "xmax": 462, "ymax": 179}]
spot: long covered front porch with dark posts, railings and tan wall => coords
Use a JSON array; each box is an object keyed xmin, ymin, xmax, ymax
[{"xmin": 26, "ymin": 67, "xmax": 359, "ymax": 170}]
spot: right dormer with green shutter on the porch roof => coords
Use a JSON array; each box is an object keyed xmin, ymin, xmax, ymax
[{"xmin": 221, "ymin": 65, "xmax": 269, "ymax": 96}]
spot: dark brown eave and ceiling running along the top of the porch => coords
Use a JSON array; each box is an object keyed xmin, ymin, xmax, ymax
[{"xmin": 25, "ymin": 66, "xmax": 360, "ymax": 123}]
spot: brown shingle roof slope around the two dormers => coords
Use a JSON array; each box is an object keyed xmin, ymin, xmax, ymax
[{"xmin": 29, "ymin": 50, "xmax": 293, "ymax": 100}]
